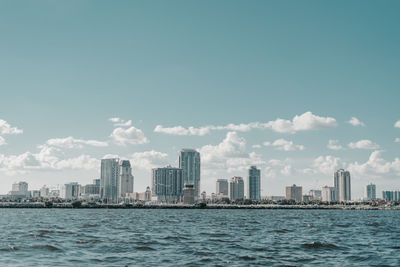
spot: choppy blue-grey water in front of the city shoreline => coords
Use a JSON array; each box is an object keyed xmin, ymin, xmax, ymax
[{"xmin": 0, "ymin": 209, "xmax": 400, "ymax": 266}]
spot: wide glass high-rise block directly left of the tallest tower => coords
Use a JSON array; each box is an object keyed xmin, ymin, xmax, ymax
[{"xmin": 151, "ymin": 166, "xmax": 184, "ymax": 202}]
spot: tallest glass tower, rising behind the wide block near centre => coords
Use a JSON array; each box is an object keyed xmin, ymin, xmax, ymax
[{"xmin": 179, "ymin": 149, "xmax": 200, "ymax": 199}]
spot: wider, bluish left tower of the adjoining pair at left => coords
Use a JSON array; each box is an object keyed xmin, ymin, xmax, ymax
[{"xmin": 100, "ymin": 158, "xmax": 119, "ymax": 203}]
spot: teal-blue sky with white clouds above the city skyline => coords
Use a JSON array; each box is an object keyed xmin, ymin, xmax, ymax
[{"xmin": 0, "ymin": 0, "xmax": 400, "ymax": 199}]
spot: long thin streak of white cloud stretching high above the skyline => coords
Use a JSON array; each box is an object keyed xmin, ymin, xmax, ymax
[{"xmin": 154, "ymin": 111, "xmax": 337, "ymax": 136}]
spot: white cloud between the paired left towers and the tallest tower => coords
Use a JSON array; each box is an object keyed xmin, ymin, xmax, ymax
[{"xmin": 131, "ymin": 150, "xmax": 168, "ymax": 171}]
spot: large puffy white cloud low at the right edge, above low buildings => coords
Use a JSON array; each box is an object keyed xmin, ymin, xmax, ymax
[{"xmin": 348, "ymin": 150, "xmax": 400, "ymax": 177}]
